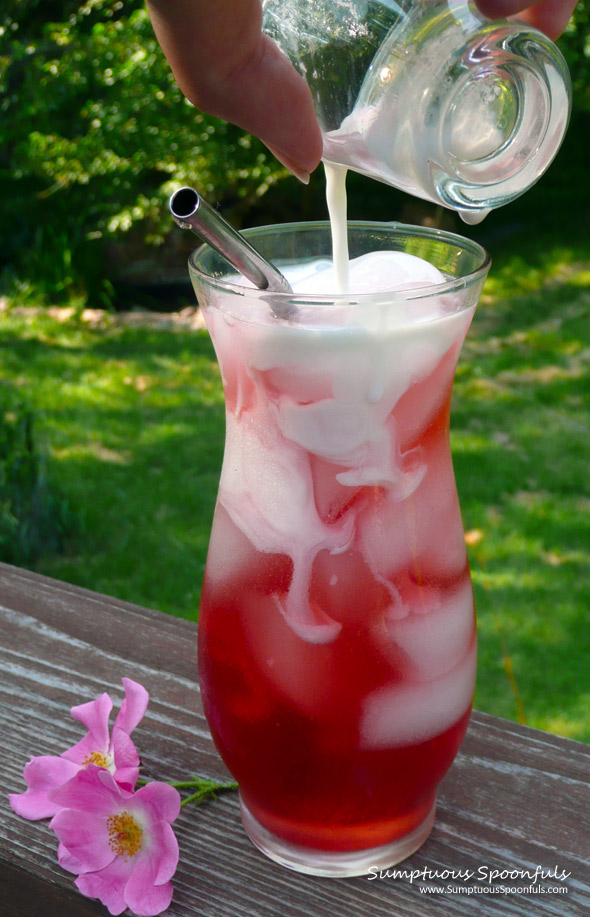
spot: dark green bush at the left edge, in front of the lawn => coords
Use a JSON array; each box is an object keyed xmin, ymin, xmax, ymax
[{"xmin": 0, "ymin": 384, "xmax": 71, "ymax": 565}]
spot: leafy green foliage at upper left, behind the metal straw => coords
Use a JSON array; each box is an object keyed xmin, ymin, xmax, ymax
[{"xmin": 0, "ymin": 0, "xmax": 286, "ymax": 303}]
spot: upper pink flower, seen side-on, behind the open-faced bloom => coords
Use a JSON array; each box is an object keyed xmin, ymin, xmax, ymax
[{"xmin": 9, "ymin": 678, "xmax": 149, "ymax": 821}]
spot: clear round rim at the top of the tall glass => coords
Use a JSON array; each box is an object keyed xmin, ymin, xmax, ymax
[{"xmin": 188, "ymin": 220, "xmax": 492, "ymax": 308}]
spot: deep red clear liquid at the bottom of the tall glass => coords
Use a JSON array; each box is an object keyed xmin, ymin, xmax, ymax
[{"xmin": 200, "ymin": 576, "xmax": 469, "ymax": 851}]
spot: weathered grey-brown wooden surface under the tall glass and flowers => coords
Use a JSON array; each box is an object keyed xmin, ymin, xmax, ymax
[{"xmin": 0, "ymin": 565, "xmax": 590, "ymax": 917}]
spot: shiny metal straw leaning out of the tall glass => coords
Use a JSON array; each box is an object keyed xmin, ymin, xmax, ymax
[{"xmin": 169, "ymin": 188, "xmax": 293, "ymax": 298}]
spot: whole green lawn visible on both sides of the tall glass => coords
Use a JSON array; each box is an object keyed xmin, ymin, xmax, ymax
[{"xmin": 0, "ymin": 247, "xmax": 590, "ymax": 741}]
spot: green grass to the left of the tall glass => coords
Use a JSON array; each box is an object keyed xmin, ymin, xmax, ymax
[{"xmin": 0, "ymin": 310, "xmax": 224, "ymax": 618}]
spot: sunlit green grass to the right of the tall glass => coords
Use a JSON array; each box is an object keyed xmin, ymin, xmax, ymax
[{"xmin": 452, "ymin": 253, "xmax": 590, "ymax": 741}]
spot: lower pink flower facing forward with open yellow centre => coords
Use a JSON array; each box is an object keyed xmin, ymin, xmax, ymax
[{"xmin": 50, "ymin": 764, "xmax": 180, "ymax": 917}]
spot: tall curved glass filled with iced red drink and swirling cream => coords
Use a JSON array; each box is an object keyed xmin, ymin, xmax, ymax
[{"xmin": 190, "ymin": 223, "xmax": 489, "ymax": 876}]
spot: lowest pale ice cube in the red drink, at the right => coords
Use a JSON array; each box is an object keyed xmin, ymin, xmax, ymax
[{"xmin": 359, "ymin": 640, "xmax": 477, "ymax": 749}]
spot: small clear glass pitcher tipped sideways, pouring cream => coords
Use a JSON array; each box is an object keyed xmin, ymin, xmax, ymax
[{"xmin": 263, "ymin": 0, "xmax": 571, "ymax": 223}]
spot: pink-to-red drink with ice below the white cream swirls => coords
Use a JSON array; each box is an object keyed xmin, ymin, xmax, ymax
[{"xmin": 199, "ymin": 334, "xmax": 475, "ymax": 851}]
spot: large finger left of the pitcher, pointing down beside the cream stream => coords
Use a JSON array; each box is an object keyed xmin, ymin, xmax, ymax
[{"xmin": 148, "ymin": 0, "xmax": 322, "ymax": 181}]
